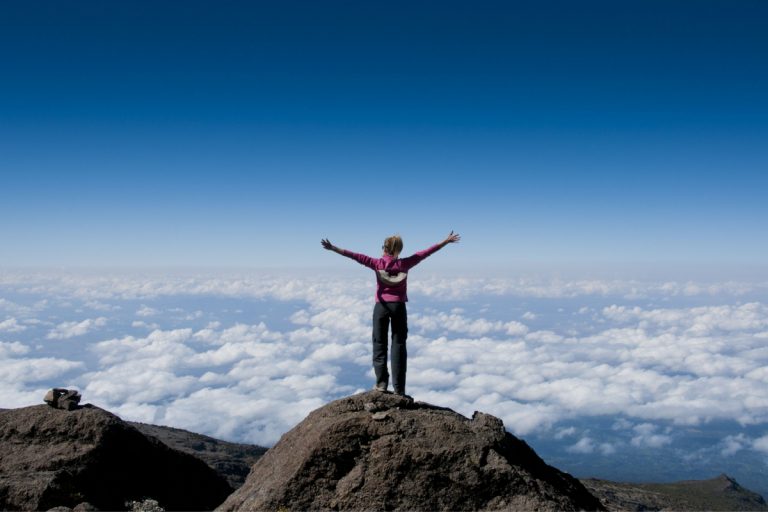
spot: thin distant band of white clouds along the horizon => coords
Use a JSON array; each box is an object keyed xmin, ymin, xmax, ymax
[{"xmin": 0, "ymin": 271, "xmax": 768, "ymax": 302}]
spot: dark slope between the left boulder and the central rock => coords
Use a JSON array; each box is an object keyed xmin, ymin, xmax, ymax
[{"xmin": 129, "ymin": 422, "xmax": 267, "ymax": 489}]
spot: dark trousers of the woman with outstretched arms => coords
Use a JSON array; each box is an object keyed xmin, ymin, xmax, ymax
[{"xmin": 373, "ymin": 302, "xmax": 408, "ymax": 394}]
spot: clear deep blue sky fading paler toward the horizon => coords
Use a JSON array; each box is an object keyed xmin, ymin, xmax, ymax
[{"xmin": 0, "ymin": 0, "xmax": 768, "ymax": 267}]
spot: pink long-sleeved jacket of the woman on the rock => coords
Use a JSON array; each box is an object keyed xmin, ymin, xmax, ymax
[{"xmin": 341, "ymin": 244, "xmax": 440, "ymax": 302}]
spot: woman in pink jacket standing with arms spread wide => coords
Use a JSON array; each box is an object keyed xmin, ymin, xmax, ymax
[{"xmin": 320, "ymin": 231, "xmax": 461, "ymax": 395}]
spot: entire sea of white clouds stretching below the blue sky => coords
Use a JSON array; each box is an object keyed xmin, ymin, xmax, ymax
[{"xmin": 0, "ymin": 270, "xmax": 768, "ymax": 488}]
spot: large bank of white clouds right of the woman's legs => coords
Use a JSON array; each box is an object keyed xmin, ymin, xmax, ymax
[{"xmin": 409, "ymin": 304, "xmax": 768, "ymax": 432}]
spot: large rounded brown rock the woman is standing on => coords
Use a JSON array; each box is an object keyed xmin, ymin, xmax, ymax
[{"xmin": 219, "ymin": 391, "xmax": 602, "ymax": 511}]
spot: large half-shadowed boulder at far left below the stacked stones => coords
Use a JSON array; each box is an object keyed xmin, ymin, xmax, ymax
[{"xmin": 0, "ymin": 405, "xmax": 232, "ymax": 510}]
